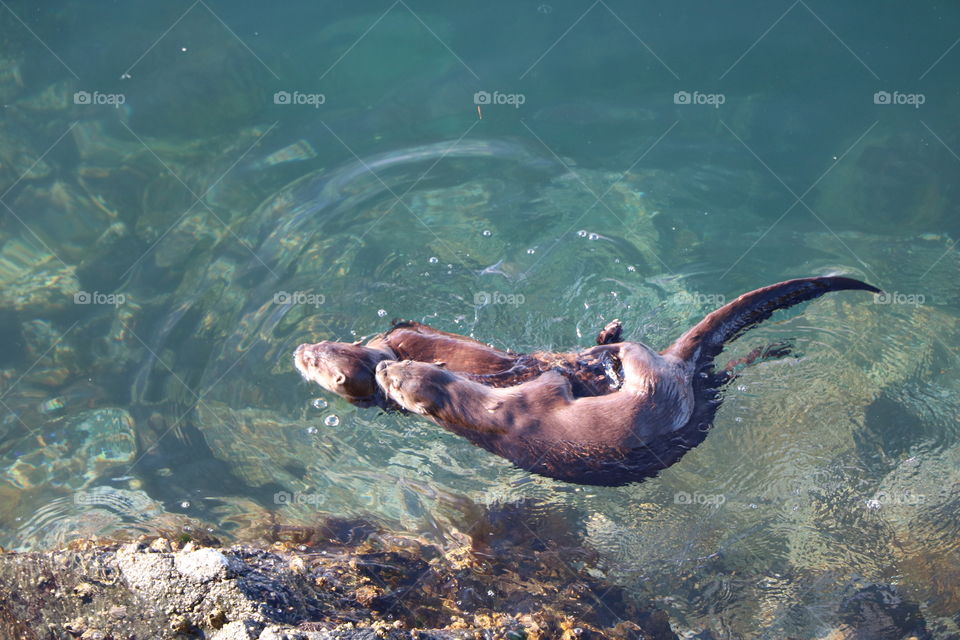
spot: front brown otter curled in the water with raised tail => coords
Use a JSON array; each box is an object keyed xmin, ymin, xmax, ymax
[{"xmin": 366, "ymin": 276, "xmax": 880, "ymax": 486}]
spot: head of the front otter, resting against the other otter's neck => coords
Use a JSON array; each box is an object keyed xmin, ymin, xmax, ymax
[{"xmin": 376, "ymin": 360, "xmax": 454, "ymax": 416}]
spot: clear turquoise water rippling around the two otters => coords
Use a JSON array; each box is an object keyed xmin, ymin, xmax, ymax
[{"xmin": 0, "ymin": 1, "xmax": 960, "ymax": 638}]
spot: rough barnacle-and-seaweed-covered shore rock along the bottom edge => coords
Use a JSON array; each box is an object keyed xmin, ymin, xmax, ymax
[{"xmin": 0, "ymin": 532, "xmax": 677, "ymax": 640}]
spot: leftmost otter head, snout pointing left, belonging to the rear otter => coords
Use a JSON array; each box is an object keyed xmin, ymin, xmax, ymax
[{"xmin": 293, "ymin": 340, "xmax": 394, "ymax": 407}]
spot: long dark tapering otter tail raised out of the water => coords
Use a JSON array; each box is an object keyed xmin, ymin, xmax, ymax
[{"xmin": 661, "ymin": 276, "xmax": 880, "ymax": 370}]
